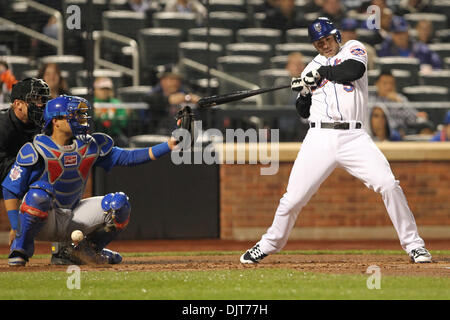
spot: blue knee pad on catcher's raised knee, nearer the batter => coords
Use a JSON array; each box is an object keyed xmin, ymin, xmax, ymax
[{"xmin": 102, "ymin": 192, "xmax": 131, "ymax": 230}]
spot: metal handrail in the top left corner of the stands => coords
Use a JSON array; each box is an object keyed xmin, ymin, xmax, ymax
[{"xmin": 0, "ymin": 0, "xmax": 64, "ymax": 55}]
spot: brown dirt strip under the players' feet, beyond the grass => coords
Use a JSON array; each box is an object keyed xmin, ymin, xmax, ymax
[{"xmin": 0, "ymin": 239, "xmax": 450, "ymax": 277}]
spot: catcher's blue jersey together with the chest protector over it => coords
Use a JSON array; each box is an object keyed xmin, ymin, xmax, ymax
[{"xmin": 2, "ymin": 133, "xmax": 129, "ymax": 209}]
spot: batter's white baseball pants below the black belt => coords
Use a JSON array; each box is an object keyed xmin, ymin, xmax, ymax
[{"xmin": 259, "ymin": 128, "xmax": 425, "ymax": 254}]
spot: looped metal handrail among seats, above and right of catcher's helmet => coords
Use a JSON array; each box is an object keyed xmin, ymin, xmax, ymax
[{"xmin": 93, "ymin": 30, "xmax": 139, "ymax": 86}]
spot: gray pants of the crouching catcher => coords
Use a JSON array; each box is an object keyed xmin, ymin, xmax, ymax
[{"xmin": 36, "ymin": 196, "xmax": 105, "ymax": 242}]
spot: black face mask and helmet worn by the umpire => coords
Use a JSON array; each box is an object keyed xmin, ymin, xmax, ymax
[{"xmin": 11, "ymin": 78, "xmax": 51, "ymax": 129}]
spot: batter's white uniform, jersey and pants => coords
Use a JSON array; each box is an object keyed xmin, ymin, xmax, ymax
[{"xmin": 259, "ymin": 40, "xmax": 425, "ymax": 254}]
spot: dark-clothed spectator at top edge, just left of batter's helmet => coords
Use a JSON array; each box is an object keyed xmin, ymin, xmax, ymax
[{"xmin": 263, "ymin": 0, "xmax": 308, "ymax": 31}]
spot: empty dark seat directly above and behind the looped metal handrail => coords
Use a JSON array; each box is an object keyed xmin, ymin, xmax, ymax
[{"xmin": 102, "ymin": 10, "xmax": 146, "ymax": 39}]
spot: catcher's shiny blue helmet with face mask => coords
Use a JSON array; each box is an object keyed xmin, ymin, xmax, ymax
[{"xmin": 44, "ymin": 95, "xmax": 92, "ymax": 136}]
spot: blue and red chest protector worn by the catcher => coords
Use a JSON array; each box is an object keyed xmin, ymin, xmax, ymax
[{"xmin": 33, "ymin": 133, "xmax": 113, "ymax": 209}]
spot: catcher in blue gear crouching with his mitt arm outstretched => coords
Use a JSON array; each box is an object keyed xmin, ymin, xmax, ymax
[{"xmin": 2, "ymin": 95, "xmax": 193, "ymax": 266}]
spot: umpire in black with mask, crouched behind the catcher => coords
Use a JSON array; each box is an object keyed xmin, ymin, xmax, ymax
[{"xmin": 0, "ymin": 78, "xmax": 50, "ymax": 245}]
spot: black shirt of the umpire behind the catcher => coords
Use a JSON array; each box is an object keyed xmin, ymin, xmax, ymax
[{"xmin": 0, "ymin": 108, "xmax": 37, "ymax": 190}]
